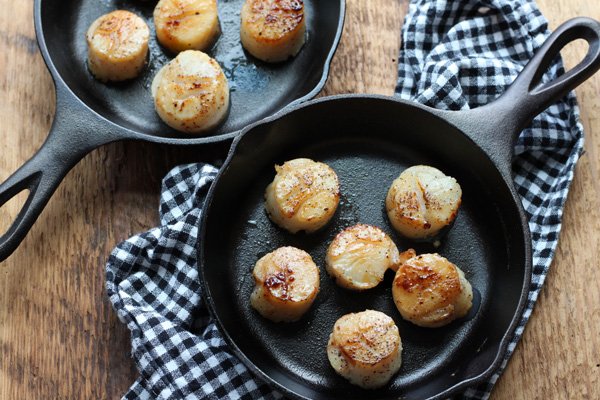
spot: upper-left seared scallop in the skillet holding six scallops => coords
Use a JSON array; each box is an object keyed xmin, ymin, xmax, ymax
[{"xmin": 265, "ymin": 158, "xmax": 340, "ymax": 233}]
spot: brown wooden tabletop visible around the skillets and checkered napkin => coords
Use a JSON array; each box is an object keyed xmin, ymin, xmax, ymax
[{"xmin": 0, "ymin": 0, "xmax": 600, "ymax": 400}]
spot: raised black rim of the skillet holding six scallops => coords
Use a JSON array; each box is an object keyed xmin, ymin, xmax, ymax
[{"xmin": 198, "ymin": 93, "xmax": 533, "ymax": 400}]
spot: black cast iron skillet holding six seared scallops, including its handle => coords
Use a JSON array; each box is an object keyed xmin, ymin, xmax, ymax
[{"xmin": 199, "ymin": 18, "xmax": 600, "ymax": 399}]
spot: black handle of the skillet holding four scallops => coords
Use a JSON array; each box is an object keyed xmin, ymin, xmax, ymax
[{"xmin": 0, "ymin": 97, "xmax": 114, "ymax": 262}]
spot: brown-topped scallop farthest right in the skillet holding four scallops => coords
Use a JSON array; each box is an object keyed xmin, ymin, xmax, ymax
[{"xmin": 240, "ymin": 0, "xmax": 306, "ymax": 62}]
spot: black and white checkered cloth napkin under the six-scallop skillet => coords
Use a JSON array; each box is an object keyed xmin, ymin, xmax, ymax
[{"xmin": 106, "ymin": 0, "xmax": 583, "ymax": 399}]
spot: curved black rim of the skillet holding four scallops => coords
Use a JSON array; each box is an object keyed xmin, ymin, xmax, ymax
[{"xmin": 33, "ymin": 0, "xmax": 346, "ymax": 145}]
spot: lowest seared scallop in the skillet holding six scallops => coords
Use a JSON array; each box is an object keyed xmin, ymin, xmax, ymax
[{"xmin": 327, "ymin": 310, "xmax": 402, "ymax": 389}]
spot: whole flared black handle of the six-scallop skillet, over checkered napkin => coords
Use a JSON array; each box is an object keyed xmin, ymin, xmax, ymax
[{"xmin": 432, "ymin": 17, "xmax": 600, "ymax": 182}]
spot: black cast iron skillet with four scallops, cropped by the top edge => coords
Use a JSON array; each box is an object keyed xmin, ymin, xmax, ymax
[{"xmin": 0, "ymin": 0, "xmax": 345, "ymax": 261}]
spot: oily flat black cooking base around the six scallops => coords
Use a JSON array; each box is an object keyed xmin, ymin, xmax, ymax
[{"xmin": 227, "ymin": 139, "xmax": 494, "ymax": 390}]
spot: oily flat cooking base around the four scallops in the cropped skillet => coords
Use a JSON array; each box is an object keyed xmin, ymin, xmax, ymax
[{"xmin": 67, "ymin": 0, "xmax": 320, "ymax": 137}]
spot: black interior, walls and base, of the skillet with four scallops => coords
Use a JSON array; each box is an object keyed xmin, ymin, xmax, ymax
[{"xmin": 38, "ymin": 0, "xmax": 344, "ymax": 140}]
